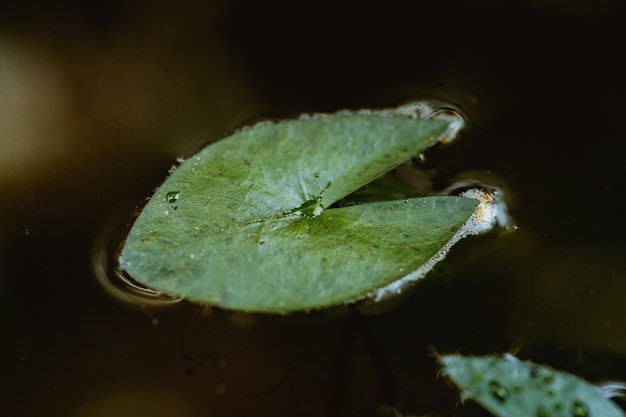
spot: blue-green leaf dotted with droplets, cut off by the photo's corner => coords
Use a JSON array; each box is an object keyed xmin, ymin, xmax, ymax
[{"xmin": 439, "ymin": 355, "xmax": 625, "ymax": 417}]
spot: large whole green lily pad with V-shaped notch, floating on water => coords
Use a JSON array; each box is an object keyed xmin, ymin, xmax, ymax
[{"xmin": 120, "ymin": 112, "xmax": 478, "ymax": 313}]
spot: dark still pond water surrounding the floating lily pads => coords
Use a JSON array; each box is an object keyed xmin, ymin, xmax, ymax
[{"xmin": 0, "ymin": 0, "xmax": 626, "ymax": 417}]
